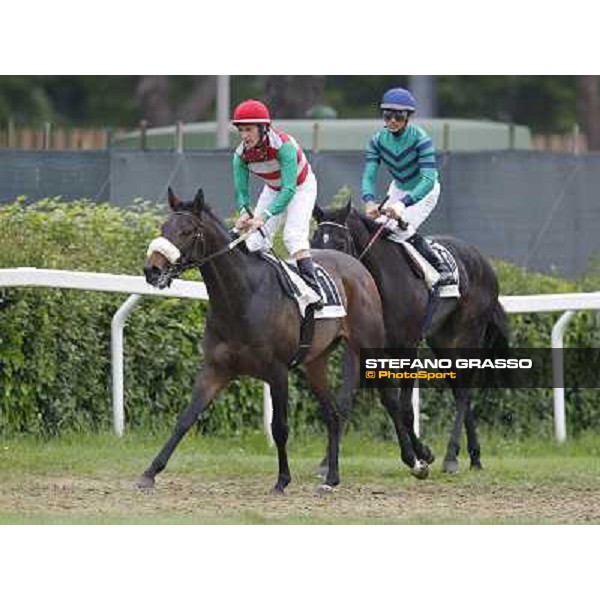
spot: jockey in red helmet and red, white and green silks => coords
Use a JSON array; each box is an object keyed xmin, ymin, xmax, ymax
[{"xmin": 232, "ymin": 100, "xmax": 320, "ymax": 308}]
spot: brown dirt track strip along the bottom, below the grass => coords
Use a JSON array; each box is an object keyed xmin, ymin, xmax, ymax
[{"xmin": 0, "ymin": 475, "xmax": 600, "ymax": 523}]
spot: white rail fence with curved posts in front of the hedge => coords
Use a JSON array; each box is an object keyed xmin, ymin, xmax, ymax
[{"xmin": 0, "ymin": 267, "xmax": 600, "ymax": 442}]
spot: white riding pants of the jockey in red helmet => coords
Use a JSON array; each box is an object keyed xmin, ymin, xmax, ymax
[{"xmin": 246, "ymin": 173, "xmax": 317, "ymax": 256}]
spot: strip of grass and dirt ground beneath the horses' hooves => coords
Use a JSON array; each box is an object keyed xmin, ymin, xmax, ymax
[{"xmin": 0, "ymin": 432, "xmax": 600, "ymax": 524}]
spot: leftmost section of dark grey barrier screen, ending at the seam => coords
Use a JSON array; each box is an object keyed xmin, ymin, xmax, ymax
[{"xmin": 0, "ymin": 149, "xmax": 110, "ymax": 202}]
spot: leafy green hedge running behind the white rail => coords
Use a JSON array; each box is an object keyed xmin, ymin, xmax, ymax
[{"xmin": 0, "ymin": 198, "xmax": 600, "ymax": 437}]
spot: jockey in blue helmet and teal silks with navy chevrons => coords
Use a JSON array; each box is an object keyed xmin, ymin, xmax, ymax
[{"xmin": 361, "ymin": 88, "xmax": 455, "ymax": 286}]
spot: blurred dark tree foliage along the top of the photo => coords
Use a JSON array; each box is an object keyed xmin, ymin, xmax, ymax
[{"xmin": 0, "ymin": 75, "xmax": 600, "ymax": 132}]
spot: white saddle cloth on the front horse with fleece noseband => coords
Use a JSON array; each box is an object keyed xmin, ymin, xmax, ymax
[{"xmin": 261, "ymin": 252, "xmax": 346, "ymax": 319}]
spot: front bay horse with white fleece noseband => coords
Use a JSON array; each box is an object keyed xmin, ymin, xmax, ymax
[{"xmin": 138, "ymin": 189, "xmax": 392, "ymax": 493}]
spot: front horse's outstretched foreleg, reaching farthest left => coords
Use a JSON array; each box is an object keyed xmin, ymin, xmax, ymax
[{"xmin": 138, "ymin": 366, "xmax": 229, "ymax": 488}]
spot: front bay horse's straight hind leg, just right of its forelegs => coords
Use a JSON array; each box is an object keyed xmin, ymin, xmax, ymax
[{"xmin": 305, "ymin": 355, "xmax": 347, "ymax": 492}]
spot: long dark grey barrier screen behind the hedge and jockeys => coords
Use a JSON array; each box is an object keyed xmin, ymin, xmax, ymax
[{"xmin": 0, "ymin": 149, "xmax": 600, "ymax": 277}]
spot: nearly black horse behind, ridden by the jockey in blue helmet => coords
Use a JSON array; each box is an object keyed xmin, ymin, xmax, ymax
[{"xmin": 312, "ymin": 203, "xmax": 508, "ymax": 473}]
